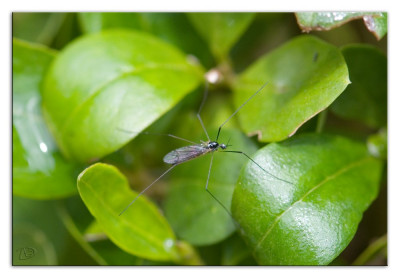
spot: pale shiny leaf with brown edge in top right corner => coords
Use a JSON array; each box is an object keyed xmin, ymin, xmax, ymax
[{"xmin": 296, "ymin": 12, "xmax": 387, "ymax": 40}]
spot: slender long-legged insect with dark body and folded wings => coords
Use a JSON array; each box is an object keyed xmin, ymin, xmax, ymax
[{"xmin": 119, "ymin": 79, "xmax": 290, "ymax": 216}]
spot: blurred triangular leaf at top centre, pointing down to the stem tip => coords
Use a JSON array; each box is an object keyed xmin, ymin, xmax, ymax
[{"xmin": 188, "ymin": 13, "xmax": 255, "ymax": 61}]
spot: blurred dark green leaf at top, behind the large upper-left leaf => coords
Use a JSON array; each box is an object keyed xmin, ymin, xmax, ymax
[{"xmin": 78, "ymin": 13, "xmax": 213, "ymax": 67}]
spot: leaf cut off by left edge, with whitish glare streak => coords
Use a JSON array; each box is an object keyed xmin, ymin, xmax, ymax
[{"xmin": 13, "ymin": 39, "xmax": 77, "ymax": 199}]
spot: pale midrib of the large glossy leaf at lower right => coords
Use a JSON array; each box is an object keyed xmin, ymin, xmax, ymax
[{"xmin": 254, "ymin": 156, "xmax": 372, "ymax": 252}]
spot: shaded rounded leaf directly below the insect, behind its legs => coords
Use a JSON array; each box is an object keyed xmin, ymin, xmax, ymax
[{"xmin": 165, "ymin": 129, "xmax": 256, "ymax": 245}]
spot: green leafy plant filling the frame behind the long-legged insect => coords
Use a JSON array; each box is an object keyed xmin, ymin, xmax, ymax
[{"xmin": 13, "ymin": 13, "xmax": 387, "ymax": 265}]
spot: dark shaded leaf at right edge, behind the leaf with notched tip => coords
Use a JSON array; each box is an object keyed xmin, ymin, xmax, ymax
[{"xmin": 332, "ymin": 44, "xmax": 387, "ymax": 127}]
